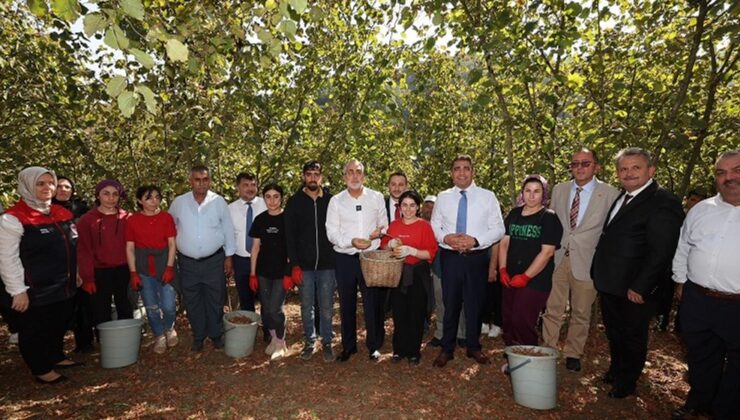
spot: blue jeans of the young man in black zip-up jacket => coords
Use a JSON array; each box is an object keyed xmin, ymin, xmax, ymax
[{"xmin": 298, "ymin": 270, "xmax": 337, "ymax": 345}]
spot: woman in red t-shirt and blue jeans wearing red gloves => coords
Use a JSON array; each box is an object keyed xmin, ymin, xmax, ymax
[{"xmin": 126, "ymin": 185, "xmax": 178, "ymax": 354}]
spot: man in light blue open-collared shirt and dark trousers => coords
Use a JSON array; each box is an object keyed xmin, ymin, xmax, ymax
[{"xmin": 169, "ymin": 166, "xmax": 235, "ymax": 352}]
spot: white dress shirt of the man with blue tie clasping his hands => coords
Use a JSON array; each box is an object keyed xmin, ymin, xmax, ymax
[{"xmin": 431, "ymin": 183, "xmax": 505, "ymax": 249}]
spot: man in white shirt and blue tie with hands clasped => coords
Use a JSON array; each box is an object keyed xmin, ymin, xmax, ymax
[{"xmin": 432, "ymin": 155, "xmax": 504, "ymax": 367}]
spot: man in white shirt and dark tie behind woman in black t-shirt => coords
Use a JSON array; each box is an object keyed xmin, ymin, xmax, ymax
[{"xmin": 229, "ymin": 172, "xmax": 267, "ymax": 311}]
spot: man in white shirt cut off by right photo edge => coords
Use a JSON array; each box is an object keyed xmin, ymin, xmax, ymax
[{"xmin": 673, "ymin": 149, "xmax": 740, "ymax": 419}]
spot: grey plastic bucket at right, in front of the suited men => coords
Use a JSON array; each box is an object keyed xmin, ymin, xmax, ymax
[{"xmin": 505, "ymin": 346, "xmax": 558, "ymax": 410}]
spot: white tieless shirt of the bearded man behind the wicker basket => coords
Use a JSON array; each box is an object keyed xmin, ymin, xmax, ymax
[{"xmin": 326, "ymin": 187, "xmax": 388, "ymax": 255}]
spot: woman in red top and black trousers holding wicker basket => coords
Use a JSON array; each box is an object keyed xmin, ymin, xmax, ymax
[{"xmin": 381, "ymin": 191, "xmax": 438, "ymax": 365}]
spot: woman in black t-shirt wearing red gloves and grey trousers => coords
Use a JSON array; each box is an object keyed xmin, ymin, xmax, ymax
[{"xmin": 249, "ymin": 184, "xmax": 293, "ymax": 360}]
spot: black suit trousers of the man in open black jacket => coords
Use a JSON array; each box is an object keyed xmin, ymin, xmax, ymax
[{"xmin": 600, "ymin": 293, "xmax": 656, "ymax": 392}]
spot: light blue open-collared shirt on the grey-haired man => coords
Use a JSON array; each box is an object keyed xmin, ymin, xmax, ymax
[{"xmin": 169, "ymin": 191, "xmax": 235, "ymax": 258}]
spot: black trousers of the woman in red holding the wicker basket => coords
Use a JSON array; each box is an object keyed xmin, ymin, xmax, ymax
[{"xmin": 390, "ymin": 263, "xmax": 431, "ymax": 357}]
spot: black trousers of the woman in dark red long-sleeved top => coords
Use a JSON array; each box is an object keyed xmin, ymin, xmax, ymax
[{"xmin": 91, "ymin": 265, "xmax": 134, "ymax": 325}]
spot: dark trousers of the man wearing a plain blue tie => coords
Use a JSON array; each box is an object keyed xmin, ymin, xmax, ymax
[{"xmin": 441, "ymin": 249, "xmax": 490, "ymax": 353}]
